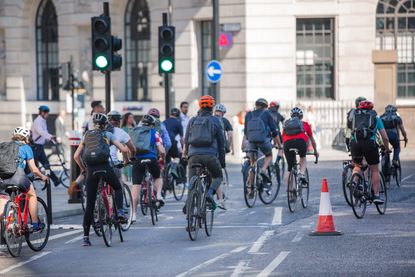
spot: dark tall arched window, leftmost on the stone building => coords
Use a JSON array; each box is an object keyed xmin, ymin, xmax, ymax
[{"xmin": 36, "ymin": 0, "xmax": 59, "ymax": 100}]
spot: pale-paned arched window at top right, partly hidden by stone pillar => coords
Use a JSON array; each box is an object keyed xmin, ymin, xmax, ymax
[{"xmin": 376, "ymin": 0, "xmax": 415, "ymax": 98}]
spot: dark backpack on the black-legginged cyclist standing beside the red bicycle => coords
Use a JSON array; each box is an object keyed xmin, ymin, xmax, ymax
[{"xmin": 82, "ymin": 130, "xmax": 110, "ymax": 165}]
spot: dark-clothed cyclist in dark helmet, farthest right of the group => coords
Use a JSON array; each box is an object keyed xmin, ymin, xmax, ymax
[{"xmin": 380, "ymin": 105, "xmax": 408, "ymax": 177}]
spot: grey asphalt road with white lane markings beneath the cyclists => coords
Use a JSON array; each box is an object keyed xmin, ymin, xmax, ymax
[{"xmin": 0, "ymin": 158, "xmax": 415, "ymax": 277}]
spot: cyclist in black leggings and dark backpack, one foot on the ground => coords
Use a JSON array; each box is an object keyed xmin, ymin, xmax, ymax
[{"xmin": 74, "ymin": 113, "xmax": 128, "ymax": 246}]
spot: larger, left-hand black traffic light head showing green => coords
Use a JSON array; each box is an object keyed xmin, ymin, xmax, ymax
[{"xmin": 91, "ymin": 15, "xmax": 112, "ymax": 71}]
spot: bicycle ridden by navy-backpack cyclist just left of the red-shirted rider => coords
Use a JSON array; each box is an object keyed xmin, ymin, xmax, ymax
[{"xmin": 244, "ymin": 150, "xmax": 280, "ymax": 208}]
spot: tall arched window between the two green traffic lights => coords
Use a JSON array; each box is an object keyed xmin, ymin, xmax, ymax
[{"xmin": 125, "ymin": 0, "xmax": 151, "ymax": 101}]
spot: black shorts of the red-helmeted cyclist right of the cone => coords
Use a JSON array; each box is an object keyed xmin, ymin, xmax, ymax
[{"xmin": 350, "ymin": 139, "xmax": 379, "ymax": 165}]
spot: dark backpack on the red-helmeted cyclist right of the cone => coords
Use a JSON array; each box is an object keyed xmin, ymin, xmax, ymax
[{"xmin": 352, "ymin": 109, "xmax": 377, "ymax": 140}]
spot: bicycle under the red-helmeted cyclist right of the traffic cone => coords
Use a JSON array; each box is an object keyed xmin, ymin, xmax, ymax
[{"xmin": 349, "ymin": 165, "xmax": 388, "ymax": 219}]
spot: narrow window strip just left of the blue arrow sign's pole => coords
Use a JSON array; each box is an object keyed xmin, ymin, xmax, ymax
[{"xmin": 200, "ymin": 21, "xmax": 212, "ymax": 95}]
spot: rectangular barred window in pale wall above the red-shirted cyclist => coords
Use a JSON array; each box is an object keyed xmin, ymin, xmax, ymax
[{"xmin": 296, "ymin": 18, "xmax": 334, "ymax": 99}]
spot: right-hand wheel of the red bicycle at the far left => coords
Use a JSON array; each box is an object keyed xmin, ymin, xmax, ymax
[{"xmin": 26, "ymin": 197, "xmax": 50, "ymax": 251}]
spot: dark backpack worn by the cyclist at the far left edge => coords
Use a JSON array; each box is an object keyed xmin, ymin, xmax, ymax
[{"xmin": 0, "ymin": 141, "xmax": 19, "ymax": 179}]
